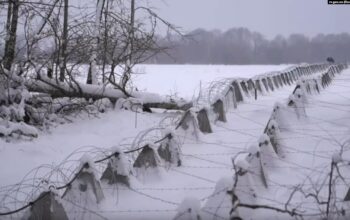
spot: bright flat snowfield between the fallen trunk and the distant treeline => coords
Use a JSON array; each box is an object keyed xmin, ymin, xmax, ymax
[{"xmin": 133, "ymin": 64, "xmax": 292, "ymax": 99}]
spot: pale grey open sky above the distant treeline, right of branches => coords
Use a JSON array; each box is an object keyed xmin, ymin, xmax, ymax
[{"xmin": 149, "ymin": 0, "xmax": 350, "ymax": 38}]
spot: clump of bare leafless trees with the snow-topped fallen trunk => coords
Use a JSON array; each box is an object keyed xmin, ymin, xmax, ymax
[{"xmin": 1, "ymin": 0, "xmax": 189, "ymax": 115}]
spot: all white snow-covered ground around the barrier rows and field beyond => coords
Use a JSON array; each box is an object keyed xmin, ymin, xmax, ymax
[{"xmin": 0, "ymin": 65, "xmax": 350, "ymax": 220}]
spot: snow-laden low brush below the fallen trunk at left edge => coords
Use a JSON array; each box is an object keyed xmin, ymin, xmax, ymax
[{"xmin": 0, "ymin": 66, "xmax": 113, "ymax": 141}]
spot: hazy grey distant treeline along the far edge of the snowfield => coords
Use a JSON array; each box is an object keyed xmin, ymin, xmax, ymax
[{"xmin": 149, "ymin": 28, "xmax": 350, "ymax": 64}]
